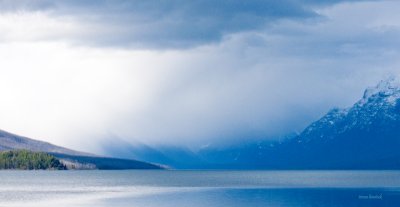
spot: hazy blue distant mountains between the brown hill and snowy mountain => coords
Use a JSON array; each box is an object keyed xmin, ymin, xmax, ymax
[{"xmin": 103, "ymin": 137, "xmax": 286, "ymax": 169}]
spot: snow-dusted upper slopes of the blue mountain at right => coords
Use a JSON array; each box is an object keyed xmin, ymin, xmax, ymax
[{"xmin": 299, "ymin": 78, "xmax": 400, "ymax": 142}]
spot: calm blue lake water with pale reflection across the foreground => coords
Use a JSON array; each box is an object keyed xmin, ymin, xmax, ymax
[{"xmin": 0, "ymin": 170, "xmax": 400, "ymax": 207}]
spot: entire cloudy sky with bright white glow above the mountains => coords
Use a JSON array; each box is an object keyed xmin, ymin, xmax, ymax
[{"xmin": 0, "ymin": 0, "xmax": 400, "ymax": 152}]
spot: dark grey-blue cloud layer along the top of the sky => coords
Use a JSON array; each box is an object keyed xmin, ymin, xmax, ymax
[{"xmin": 0, "ymin": 0, "xmax": 376, "ymax": 49}]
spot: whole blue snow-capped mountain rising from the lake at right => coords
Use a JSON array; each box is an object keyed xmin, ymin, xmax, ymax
[{"xmin": 283, "ymin": 78, "xmax": 400, "ymax": 169}]
